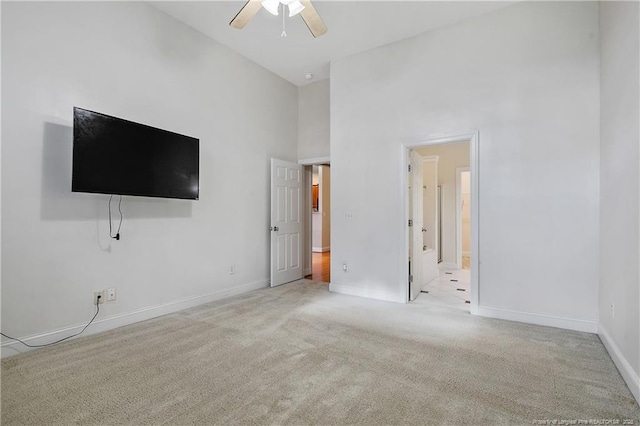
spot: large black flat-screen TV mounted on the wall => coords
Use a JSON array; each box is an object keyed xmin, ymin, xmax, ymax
[{"xmin": 71, "ymin": 107, "xmax": 200, "ymax": 200}]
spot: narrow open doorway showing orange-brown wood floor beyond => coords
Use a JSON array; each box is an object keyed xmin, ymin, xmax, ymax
[{"xmin": 305, "ymin": 163, "xmax": 331, "ymax": 283}]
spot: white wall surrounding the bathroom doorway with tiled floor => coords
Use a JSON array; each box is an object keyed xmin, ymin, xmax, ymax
[{"xmin": 331, "ymin": 2, "xmax": 599, "ymax": 331}]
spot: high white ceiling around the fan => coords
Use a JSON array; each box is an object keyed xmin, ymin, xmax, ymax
[{"xmin": 151, "ymin": 0, "xmax": 513, "ymax": 86}]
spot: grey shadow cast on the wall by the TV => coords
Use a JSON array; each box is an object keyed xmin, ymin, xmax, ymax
[{"xmin": 40, "ymin": 123, "xmax": 193, "ymax": 221}]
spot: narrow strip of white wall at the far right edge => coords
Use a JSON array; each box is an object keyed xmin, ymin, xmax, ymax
[{"xmin": 599, "ymin": 2, "xmax": 640, "ymax": 401}]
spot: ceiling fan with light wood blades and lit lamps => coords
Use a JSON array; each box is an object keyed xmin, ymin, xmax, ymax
[{"xmin": 229, "ymin": 0, "xmax": 327, "ymax": 37}]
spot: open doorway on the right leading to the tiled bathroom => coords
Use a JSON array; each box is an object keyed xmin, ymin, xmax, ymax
[{"xmin": 406, "ymin": 134, "xmax": 478, "ymax": 313}]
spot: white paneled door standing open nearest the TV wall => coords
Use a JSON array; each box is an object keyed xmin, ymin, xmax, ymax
[{"xmin": 271, "ymin": 158, "xmax": 303, "ymax": 287}]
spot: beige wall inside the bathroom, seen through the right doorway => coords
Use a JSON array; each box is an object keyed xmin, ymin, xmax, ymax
[{"xmin": 416, "ymin": 142, "xmax": 470, "ymax": 265}]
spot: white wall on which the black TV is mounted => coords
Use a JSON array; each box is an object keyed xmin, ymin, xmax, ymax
[{"xmin": 2, "ymin": 2, "xmax": 298, "ymax": 355}]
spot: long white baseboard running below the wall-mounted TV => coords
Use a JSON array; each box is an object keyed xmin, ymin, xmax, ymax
[{"xmin": 0, "ymin": 280, "xmax": 269, "ymax": 358}]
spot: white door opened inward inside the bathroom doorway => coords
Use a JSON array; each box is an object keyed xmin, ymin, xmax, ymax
[{"xmin": 409, "ymin": 150, "xmax": 424, "ymax": 300}]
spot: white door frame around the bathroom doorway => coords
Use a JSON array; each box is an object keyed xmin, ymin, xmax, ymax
[{"xmin": 398, "ymin": 131, "xmax": 480, "ymax": 315}]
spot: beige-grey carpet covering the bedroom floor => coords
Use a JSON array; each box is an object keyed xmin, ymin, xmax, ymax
[{"xmin": 1, "ymin": 280, "xmax": 640, "ymax": 425}]
